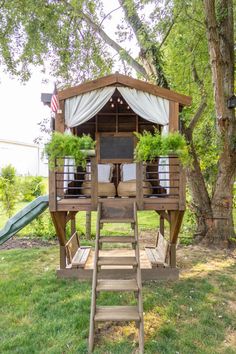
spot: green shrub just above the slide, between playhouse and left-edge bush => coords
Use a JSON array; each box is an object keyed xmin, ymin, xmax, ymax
[{"xmin": 20, "ymin": 176, "xmax": 45, "ymax": 202}]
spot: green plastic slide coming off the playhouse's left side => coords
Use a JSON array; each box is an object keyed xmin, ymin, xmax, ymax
[{"xmin": 0, "ymin": 195, "xmax": 48, "ymax": 245}]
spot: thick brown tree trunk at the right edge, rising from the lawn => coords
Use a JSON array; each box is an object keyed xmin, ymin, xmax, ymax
[{"xmin": 204, "ymin": 0, "xmax": 236, "ymax": 245}]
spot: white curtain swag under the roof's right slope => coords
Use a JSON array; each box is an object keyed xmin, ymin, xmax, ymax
[{"xmin": 117, "ymin": 87, "xmax": 169, "ymax": 125}]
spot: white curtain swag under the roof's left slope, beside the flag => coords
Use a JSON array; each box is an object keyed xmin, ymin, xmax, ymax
[{"xmin": 65, "ymin": 86, "xmax": 116, "ymax": 128}]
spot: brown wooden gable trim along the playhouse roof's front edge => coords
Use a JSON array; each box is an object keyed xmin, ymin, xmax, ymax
[{"xmin": 58, "ymin": 74, "xmax": 192, "ymax": 106}]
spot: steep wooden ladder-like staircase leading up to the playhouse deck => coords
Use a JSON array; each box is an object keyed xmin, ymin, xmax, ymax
[{"xmin": 89, "ymin": 202, "xmax": 144, "ymax": 353}]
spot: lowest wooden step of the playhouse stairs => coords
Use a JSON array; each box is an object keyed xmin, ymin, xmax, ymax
[{"xmin": 94, "ymin": 306, "xmax": 140, "ymax": 321}]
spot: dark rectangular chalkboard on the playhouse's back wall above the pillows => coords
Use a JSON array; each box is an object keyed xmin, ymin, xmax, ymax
[{"xmin": 100, "ymin": 135, "xmax": 134, "ymax": 160}]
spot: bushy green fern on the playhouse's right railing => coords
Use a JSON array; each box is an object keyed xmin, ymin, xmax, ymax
[{"xmin": 134, "ymin": 129, "xmax": 190, "ymax": 166}]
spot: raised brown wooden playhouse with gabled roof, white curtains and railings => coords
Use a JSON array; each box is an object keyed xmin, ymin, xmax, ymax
[{"xmin": 49, "ymin": 74, "xmax": 191, "ymax": 280}]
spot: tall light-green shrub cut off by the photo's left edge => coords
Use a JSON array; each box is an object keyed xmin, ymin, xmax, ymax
[{"xmin": 0, "ymin": 165, "xmax": 19, "ymax": 217}]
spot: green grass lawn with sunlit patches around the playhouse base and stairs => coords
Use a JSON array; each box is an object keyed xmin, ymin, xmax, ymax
[{"xmin": 0, "ymin": 246, "xmax": 236, "ymax": 354}]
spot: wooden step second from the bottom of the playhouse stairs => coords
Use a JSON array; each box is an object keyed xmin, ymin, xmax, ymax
[{"xmin": 96, "ymin": 279, "xmax": 138, "ymax": 291}]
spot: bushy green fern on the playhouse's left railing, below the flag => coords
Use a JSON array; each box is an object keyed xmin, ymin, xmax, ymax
[{"xmin": 44, "ymin": 132, "xmax": 95, "ymax": 169}]
